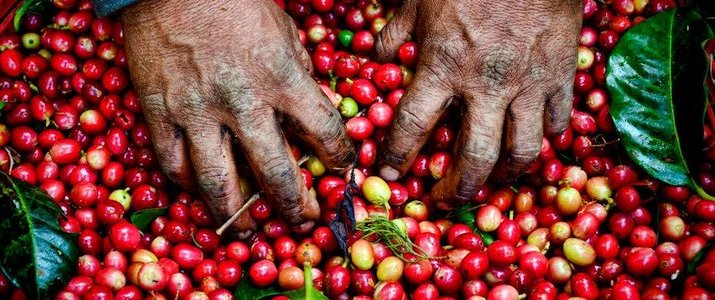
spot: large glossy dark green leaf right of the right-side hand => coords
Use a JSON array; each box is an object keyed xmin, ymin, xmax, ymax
[{"xmin": 606, "ymin": 8, "xmax": 713, "ymax": 198}]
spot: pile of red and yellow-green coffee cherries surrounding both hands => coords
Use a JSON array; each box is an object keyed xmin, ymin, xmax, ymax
[{"xmin": 0, "ymin": 0, "xmax": 715, "ymax": 300}]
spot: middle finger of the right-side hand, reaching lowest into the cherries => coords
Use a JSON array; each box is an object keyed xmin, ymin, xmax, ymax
[{"xmin": 432, "ymin": 94, "xmax": 506, "ymax": 203}]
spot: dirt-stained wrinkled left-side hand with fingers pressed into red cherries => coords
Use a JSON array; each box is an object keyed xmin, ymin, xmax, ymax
[{"xmin": 122, "ymin": 0, "xmax": 354, "ymax": 233}]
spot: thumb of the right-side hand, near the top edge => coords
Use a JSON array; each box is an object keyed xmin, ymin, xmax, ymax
[{"xmin": 375, "ymin": 0, "xmax": 417, "ymax": 61}]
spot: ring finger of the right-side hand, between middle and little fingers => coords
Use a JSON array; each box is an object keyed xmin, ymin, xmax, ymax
[{"xmin": 492, "ymin": 93, "xmax": 544, "ymax": 182}]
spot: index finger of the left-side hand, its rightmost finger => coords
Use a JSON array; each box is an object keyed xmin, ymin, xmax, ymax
[{"xmin": 280, "ymin": 74, "xmax": 355, "ymax": 172}]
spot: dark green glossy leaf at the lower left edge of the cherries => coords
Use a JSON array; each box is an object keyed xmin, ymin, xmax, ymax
[{"xmin": 0, "ymin": 172, "xmax": 79, "ymax": 299}]
